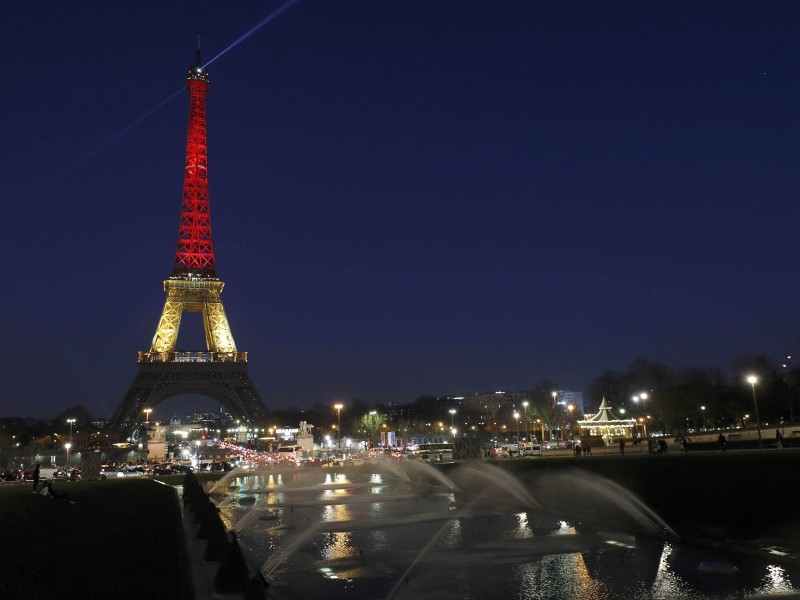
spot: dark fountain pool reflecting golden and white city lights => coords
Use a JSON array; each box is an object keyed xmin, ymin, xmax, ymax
[{"xmin": 218, "ymin": 465, "xmax": 798, "ymax": 600}]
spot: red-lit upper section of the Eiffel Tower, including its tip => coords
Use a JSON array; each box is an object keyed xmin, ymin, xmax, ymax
[{"xmin": 173, "ymin": 44, "xmax": 216, "ymax": 278}]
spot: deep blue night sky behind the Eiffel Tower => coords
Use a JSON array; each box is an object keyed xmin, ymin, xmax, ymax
[{"xmin": 0, "ymin": 0, "xmax": 800, "ymax": 416}]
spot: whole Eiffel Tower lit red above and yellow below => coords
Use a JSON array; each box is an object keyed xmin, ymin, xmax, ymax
[{"xmin": 111, "ymin": 39, "xmax": 266, "ymax": 428}]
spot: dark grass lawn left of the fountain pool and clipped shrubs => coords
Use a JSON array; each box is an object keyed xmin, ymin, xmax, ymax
[{"xmin": 0, "ymin": 477, "xmax": 185, "ymax": 600}]
